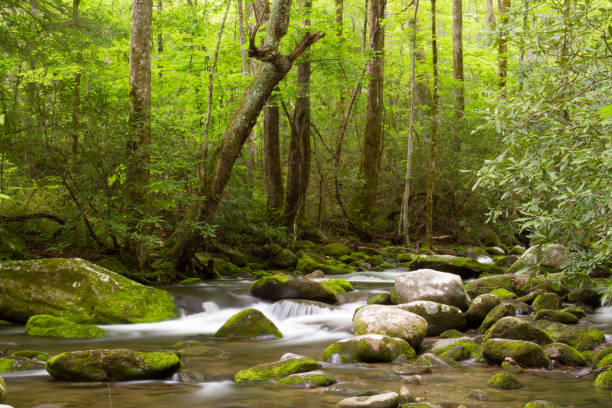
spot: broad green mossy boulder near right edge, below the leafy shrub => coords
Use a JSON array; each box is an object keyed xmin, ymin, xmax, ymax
[{"xmin": 535, "ymin": 320, "xmax": 606, "ymax": 351}]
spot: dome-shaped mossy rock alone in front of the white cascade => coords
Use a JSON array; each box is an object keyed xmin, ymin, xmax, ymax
[{"xmin": 215, "ymin": 309, "xmax": 283, "ymax": 338}]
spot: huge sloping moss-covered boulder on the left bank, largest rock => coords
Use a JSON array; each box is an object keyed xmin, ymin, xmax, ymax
[{"xmin": 0, "ymin": 258, "xmax": 176, "ymax": 324}]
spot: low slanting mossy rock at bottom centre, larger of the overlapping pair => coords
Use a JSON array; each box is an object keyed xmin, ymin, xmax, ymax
[{"xmin": 234, "ymin": 357, "xmax": 321, "ymax": 383}]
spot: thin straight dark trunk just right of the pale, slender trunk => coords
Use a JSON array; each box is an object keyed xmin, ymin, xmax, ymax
[{"xmin": 425, "ymin": 0, "xmax": 440, "ymax": 250}]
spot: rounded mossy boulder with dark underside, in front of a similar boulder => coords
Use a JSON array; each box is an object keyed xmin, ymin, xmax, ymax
[{"xmin": 482, "ymin": 339, "xmax": 550, "ymax": 368}]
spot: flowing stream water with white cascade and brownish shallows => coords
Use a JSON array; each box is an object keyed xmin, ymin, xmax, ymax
[{"xmin": 0, "ymin": 270, "xmax": 612, "ymax": 408}]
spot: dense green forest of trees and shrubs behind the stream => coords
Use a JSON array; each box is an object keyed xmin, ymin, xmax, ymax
[{"xmin": 0, "ymin": 0, "xmax": 612, "ymax": 280}]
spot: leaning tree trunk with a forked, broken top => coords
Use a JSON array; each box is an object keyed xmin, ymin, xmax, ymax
[{"xmin": 170, "ymin": 0, "xmax": 324, "ymax": 274}]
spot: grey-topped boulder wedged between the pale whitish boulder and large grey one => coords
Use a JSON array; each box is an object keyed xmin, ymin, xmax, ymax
[{"xmin": 396, "ymin": 300, "xmax": 466, "ymax": 336}]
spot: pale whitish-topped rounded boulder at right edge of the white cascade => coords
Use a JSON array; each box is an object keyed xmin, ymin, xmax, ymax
[{"xmin": 353, "ymin": 305, "xmax": 427, "ymax": 347}]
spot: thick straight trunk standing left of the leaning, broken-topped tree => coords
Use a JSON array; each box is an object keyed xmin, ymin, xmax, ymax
[{"xmin": 126, "ymin": 0, "xmax": 153, "ymax": 267}]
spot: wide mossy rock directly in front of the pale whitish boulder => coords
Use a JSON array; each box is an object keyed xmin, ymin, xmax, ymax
[{"xmin": 323, "ymin": 334, "xmax": 415, "ymax": 363}]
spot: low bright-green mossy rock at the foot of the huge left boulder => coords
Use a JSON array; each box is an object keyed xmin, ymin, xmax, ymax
[{"xmin": 25, "ymin": 315, "xmax": 108, "ymax": 339}]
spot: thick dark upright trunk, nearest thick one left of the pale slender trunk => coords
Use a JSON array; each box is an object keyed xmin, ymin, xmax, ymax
[{"xmin": 356, "ymin": 0, "xmax": 386, "ymax": 222}]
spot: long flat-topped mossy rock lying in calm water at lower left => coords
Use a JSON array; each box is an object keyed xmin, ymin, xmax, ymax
[{"xmin": 46, "ymin": 349, "xmax": 181, "ymax": 381}]
